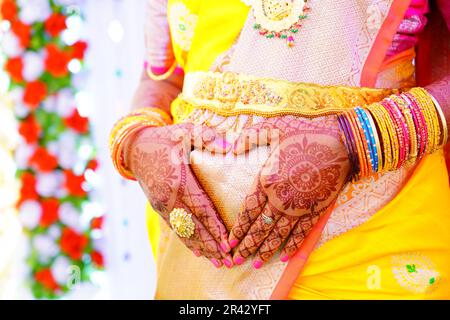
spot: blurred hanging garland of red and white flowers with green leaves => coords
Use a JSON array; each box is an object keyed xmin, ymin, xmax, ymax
[{"xmin": 0, "ymin": 0, "xmax": 103, "ymax": 298}]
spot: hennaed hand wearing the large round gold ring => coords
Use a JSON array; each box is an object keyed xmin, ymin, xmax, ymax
[{"xmin": 125, "ymin": 124, "xmax": 232, "ymax": 267}]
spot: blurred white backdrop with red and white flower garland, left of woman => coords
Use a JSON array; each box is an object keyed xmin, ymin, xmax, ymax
[{"xmin": 0, "ymin": 0, "xmax": 155, "ymax": 299}]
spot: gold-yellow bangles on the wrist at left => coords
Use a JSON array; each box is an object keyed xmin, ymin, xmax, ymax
[{"xmin": 109, "ymin": 107, "xmax": 172, "ymax": 180}]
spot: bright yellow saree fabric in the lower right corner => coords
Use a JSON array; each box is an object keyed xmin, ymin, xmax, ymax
[{"xmin": 289, "ymin": 151, "xmax": 450, "ymax": 299}]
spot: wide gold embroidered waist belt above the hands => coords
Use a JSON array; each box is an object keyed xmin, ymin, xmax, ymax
[{"xmin": 179, "ymin": 72, "xmax": 400, "ymax": 117}]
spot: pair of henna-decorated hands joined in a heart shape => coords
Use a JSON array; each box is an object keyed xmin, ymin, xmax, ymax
[{"xmin": 125, "ymin": 116, "xmax": 350, "ymax": 268}]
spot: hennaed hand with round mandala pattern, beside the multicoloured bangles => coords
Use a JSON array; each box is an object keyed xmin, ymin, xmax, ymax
[{"xmin": 230, "ymin": 116, "xmax": 350, "ymax": 268}]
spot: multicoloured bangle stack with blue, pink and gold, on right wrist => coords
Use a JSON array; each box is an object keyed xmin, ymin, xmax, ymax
[{"xmin": 338, "ymin": 88, "xmax": 448, "ymax": 180}]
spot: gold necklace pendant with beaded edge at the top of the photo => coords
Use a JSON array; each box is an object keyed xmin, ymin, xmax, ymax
[{"xmin": 241, "ymin": 0, "xmax": 310, "ymax": 47}]
